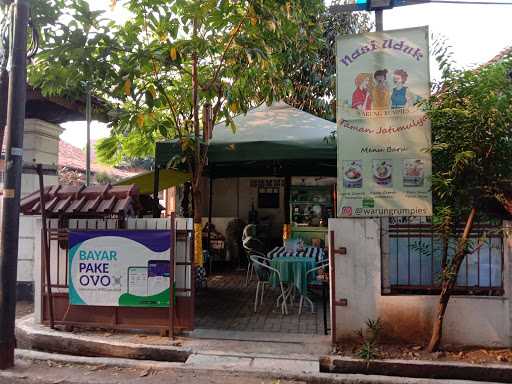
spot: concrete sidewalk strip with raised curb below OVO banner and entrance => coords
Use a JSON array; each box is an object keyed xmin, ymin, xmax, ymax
[{"xmin": 16, "ymin": 316, "xmax": 332, "ymax": 361}]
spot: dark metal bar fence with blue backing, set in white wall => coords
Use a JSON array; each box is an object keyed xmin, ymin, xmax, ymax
[{"xmin": 383, "ymin": 217, "xmax": 504, "ymax": 295}]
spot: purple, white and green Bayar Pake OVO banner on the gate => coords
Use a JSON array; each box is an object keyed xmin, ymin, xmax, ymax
[{"xmin": 68, "ymin": 230, "xmax": 172, "ymax": 307}]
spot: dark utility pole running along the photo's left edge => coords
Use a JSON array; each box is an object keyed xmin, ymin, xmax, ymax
[{"xmin": 0, "ymin": 0, "xmax": 29, "ymax": 369}]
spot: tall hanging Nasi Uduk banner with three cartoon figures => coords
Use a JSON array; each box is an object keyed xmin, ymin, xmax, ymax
[{"xmin": 336, "ymin": 27, "xmax": 432, "ymax": 217}]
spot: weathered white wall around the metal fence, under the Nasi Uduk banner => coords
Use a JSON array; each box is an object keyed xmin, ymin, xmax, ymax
[{"xmin": 329, "ymin": 219, "xmax": 512, "ymax": 347}]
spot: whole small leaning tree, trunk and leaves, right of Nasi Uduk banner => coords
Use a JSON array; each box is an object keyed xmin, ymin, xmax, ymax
[{"xmin": 426, "ymin": 48, "xmax": 512, "ymax": 352}]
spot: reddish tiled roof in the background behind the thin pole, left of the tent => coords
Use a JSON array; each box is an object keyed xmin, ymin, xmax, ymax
[{"xmin": 59, "ymin": 140, "xmax": 140, "ymax": 178}]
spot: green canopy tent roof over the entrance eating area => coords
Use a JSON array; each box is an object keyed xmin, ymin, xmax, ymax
[{"xmin": 156, "ymin": 102, "xmax": 336, "ymax": 172}]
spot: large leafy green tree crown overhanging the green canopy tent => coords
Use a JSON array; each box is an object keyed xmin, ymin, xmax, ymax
[{"xmin": 30, "ymin": 0, "xmax": 348, "ymax": 172}]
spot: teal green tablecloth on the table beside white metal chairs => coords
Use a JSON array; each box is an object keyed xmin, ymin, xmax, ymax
[{"xmin": 270, "ymin": 256, "xmax": 316, "ymax": 296}]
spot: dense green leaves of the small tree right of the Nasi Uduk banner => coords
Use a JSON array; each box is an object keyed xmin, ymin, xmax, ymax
[{"xmin": 426, "ymin": 47, "xmax": 512, "ymax": 221}]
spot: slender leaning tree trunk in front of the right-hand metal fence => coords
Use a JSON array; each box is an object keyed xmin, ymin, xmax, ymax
[{"xmin": 427, "ymin": 208, "xmax": 476, "ymax": 352}]
